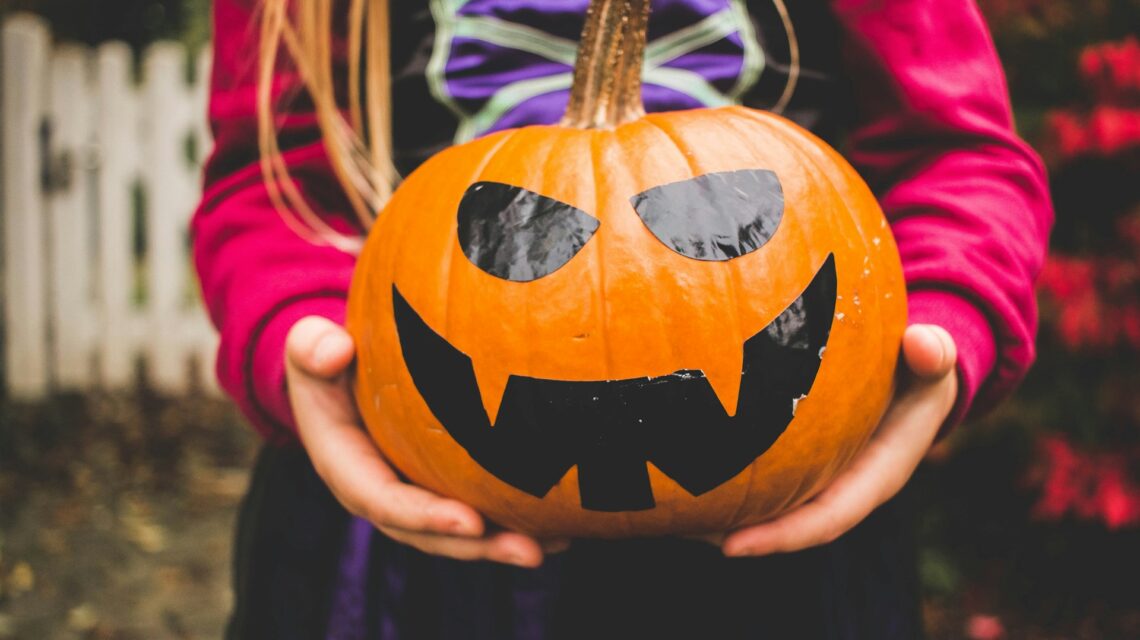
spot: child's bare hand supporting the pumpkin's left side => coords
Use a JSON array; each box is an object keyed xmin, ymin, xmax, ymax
[{"xmin": 285, "ymin": 316, "xmax": 565, "ymax": 567}]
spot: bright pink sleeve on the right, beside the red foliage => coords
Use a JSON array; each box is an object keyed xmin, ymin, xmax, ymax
[{"xmin": 834, "ymin": 0, "xmax": 1052, "ymax": 426}]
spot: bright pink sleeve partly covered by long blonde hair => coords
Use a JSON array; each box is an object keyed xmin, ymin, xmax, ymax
[{"xmin": 192, "ymin": 0, "xmax": 355, "ymax": 440}]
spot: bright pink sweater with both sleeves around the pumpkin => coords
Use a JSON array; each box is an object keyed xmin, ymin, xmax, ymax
[{"xmin": 193, "ymin": 0, "xmax": 1052, "ymax": 441}]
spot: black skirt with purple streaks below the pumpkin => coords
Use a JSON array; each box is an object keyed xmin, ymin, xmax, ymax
[{"xmin": 227, "ymin": 447, "xmax": 922, "ymax": 640}]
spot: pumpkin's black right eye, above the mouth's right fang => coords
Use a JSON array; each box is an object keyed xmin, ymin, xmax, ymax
[{"xmin": 629, "ymin": 169, "xmax": 784, "ymax": 261}]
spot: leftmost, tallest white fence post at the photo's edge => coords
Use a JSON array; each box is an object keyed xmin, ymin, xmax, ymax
[{"xmin": 0, "ymin": 15, "xmax": 50, "ymax": 398}]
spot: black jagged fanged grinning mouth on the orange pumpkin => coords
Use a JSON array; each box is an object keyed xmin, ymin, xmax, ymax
[{"xmin": 392, "ymin": 256, "xmax": 836, "ymax": 511}]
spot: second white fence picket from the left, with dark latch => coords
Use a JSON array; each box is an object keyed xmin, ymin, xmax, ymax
[{"xmin": 48, "ymin": 46, "xmax": 96, "ymax": 389}]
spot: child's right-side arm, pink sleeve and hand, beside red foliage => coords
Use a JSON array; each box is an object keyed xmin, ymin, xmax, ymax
[{"xmin": 724, "ymin": 0, "xmax": 1052, "ymax": 556}]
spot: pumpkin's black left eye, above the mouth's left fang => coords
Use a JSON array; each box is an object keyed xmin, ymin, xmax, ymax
[{"xmin": 458, "ymin": 181, "xmax": 599, "ymax": 282}]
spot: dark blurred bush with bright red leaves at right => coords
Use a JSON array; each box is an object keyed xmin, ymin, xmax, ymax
[{"xmin": 915, "ymin": 0, "xmax": 1140, "ymax": 638}]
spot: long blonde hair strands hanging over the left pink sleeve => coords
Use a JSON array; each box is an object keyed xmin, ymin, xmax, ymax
[{"xmin": 258, "ymin": 0, "xmax": 397, "ymax": 253}]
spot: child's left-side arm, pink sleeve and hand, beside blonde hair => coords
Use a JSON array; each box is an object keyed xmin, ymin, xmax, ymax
[{"xmin": 193, "ymin": 0, "xmax": 549, "ymax": 566}]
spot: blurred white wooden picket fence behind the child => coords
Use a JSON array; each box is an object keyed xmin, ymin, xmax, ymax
[{"xmin": 0, "ymin": 14, "xmax": 217, "ymax": 399}]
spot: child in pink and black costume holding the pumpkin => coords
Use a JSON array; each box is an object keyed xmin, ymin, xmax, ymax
[{"xmin": 194, "ymin": 0, "xmax": 1051, "ymax": 640}]
